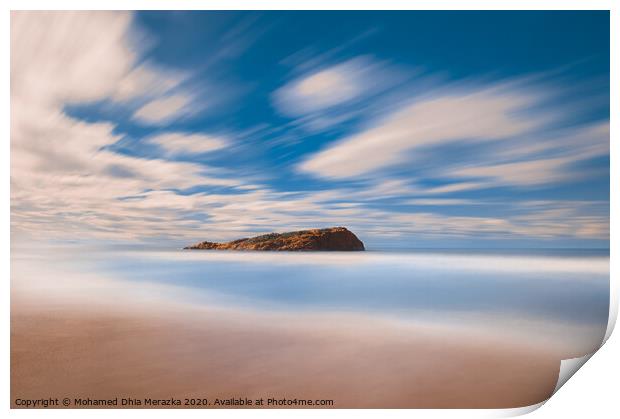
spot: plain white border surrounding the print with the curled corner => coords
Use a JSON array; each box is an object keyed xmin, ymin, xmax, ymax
[{"xmin": 0, "ymin": 0, "xmax": 620, "ymax": 418}]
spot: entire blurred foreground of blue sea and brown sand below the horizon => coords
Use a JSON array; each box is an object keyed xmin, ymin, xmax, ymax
[{"xmin": 11, "ymin": 250, "xmax": 609, "ymax": 408}]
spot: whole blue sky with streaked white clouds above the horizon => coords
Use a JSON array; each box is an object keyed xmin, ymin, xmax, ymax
[{"xmin": 11, "ymin": 11, "xmax": 610, "ymax": 249}]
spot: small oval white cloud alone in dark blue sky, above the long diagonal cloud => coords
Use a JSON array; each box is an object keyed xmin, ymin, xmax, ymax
[{"xmin": 274, "ymin": 57, "xmax": 381, "ymax": 116}]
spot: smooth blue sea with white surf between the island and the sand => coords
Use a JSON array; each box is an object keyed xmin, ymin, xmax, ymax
[{"xmin": 13, "ymin": 248, "xmax": 609, "ymax": 354}]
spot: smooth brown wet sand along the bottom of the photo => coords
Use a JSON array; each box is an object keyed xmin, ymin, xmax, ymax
[{"xmin": 11, "ymin": 295, "xmax": 566, "ymax": 408}]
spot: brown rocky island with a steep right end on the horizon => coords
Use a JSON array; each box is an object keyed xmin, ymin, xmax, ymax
[{"xmin": 184, "ymin": 227, "xmax": 365, "ymax": 251}]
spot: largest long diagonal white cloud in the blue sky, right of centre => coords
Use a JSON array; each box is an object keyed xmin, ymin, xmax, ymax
[{"xmin": 299, "ymin": 88, "xmax": 540, "ymax": 178}]
